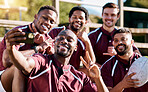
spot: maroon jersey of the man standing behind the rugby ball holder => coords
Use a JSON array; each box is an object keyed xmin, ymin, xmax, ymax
[{"xmin": 88, "ymin": 27, "xmax": 138, "ymax": 65}]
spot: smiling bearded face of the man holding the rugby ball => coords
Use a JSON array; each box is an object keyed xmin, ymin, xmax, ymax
[{"xmin": 113, "ymin": 33, "xmax": 133, "ymax": 56}]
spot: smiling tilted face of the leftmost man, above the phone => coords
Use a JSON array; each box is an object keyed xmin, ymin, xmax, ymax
[{"xmin": 35, "ymin": 9, "xmax": 57, "ymax": 34}]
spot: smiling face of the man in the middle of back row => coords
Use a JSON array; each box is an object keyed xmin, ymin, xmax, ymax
[{"xmin": 69, "ymin": 10, "xmax": 87, "ymax": 32}]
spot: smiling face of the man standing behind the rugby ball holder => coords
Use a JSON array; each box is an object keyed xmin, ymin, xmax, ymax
[{"xmin": 102, "ymin": 8, "xmax": 119, "ymax": 27}]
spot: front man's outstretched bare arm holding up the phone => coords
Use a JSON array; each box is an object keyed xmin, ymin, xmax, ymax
[{"xmin": 6, "ymin": 30, "xmax": 35, "ymax": 74}]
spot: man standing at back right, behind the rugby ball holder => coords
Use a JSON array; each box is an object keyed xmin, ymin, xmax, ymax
[{"xmin": 88, "ymin": 3, "xmax": 140, "ymax": 66}]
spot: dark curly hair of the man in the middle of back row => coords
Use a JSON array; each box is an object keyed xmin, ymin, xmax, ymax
[{"xmin": 69, "ymin": 6, "xmax": 89, "ymax": 20}]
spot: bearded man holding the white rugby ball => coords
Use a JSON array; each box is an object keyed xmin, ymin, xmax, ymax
[{"xmin": 101, "ymin": 28, "xmax": 148, "ymax": 92}]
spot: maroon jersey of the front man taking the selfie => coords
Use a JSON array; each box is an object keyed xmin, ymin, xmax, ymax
[{"xmin": 27, "ymin": 54, "xmax": 97, "ymax": 92}]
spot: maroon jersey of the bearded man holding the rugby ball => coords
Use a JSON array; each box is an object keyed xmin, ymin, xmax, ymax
[{"xmin": 101, "ymin": 53, "xmax": 148, "ymax": 92}]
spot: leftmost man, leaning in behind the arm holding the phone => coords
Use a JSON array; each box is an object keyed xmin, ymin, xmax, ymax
[{"xmin": 0, "ymin": 5, "xmax": 58, "ymax": 92}]
